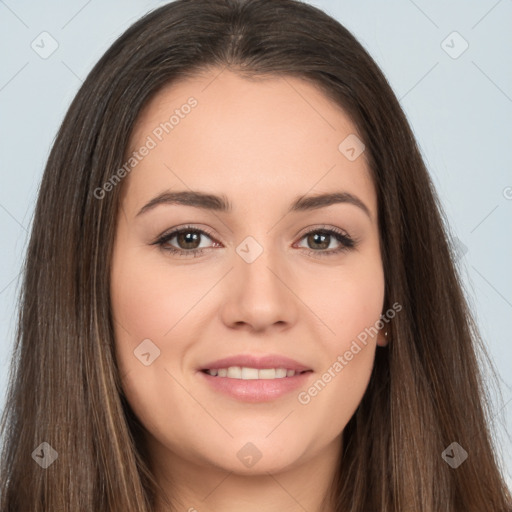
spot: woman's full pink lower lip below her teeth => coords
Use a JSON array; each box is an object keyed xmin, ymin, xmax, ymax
[{"xmin": 198, "ymin": 371, "xmax": 313, "ymax": 402}]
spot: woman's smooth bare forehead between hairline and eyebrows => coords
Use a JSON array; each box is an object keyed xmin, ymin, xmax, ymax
[{"xmin": 125, "ymin": 69, "xmax": 376, "ymax": 218}]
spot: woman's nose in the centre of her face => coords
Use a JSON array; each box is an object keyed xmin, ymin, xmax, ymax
[{"xmin": 221, "ymin": 239, "xmax": 300, "ymax": 331}]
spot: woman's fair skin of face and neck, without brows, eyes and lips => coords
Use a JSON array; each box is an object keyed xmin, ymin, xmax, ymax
[{"xmin": 111, "ymin": 69, "xmax": 386, "ymax": 512}]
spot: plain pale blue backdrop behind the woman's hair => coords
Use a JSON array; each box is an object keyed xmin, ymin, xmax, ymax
[{"xmin": 0, "ymin": 0, "xmax": 512, "ymax": 487}]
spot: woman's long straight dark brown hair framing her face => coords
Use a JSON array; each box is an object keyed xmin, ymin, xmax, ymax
[{"xmin": 0, "ymin": 0, "xmax": 512, "ymax": 512}]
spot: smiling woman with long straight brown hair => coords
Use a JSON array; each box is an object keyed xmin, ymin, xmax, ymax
[{"xmin": 0, "ymin": 0, "xmax": 512, "ymax": 512}]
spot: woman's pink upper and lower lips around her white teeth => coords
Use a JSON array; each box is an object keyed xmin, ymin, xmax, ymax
[{"xmin": 197, "ymin": 354, "xmax": 313, "ymax": 402}]
